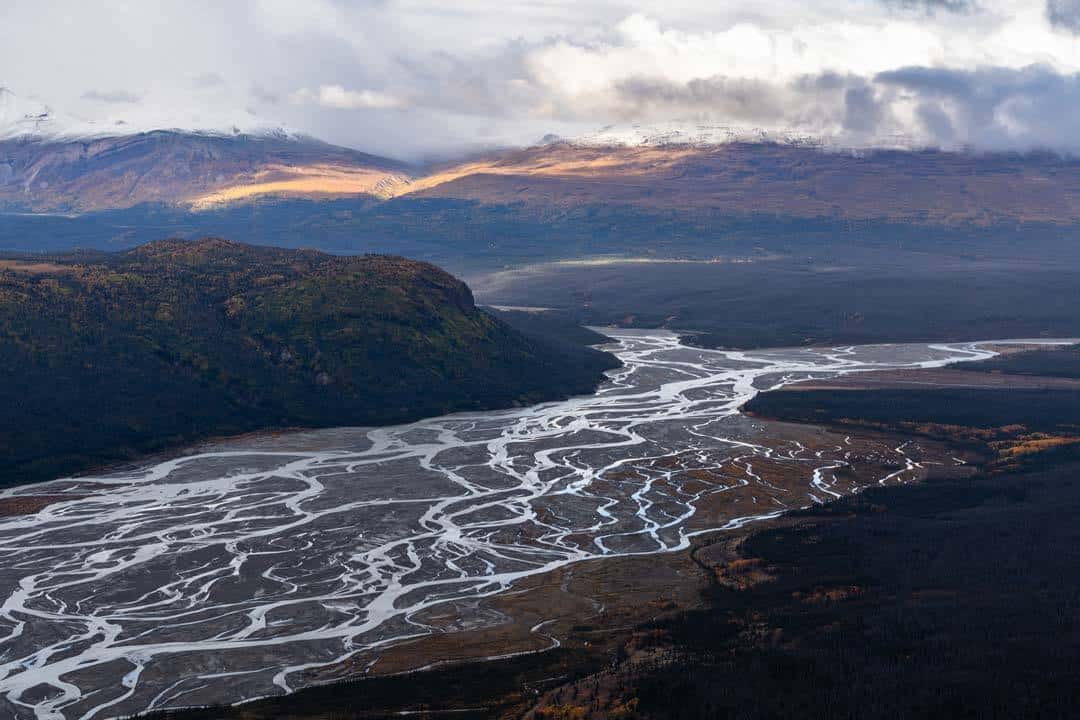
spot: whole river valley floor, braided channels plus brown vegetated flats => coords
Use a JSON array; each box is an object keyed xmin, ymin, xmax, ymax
[{"xmin": 0, "ymin": 330, "xmax": 1071, "ymax": 718}]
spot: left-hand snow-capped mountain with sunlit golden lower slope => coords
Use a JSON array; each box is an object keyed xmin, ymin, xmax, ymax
[{"xmin": 0, "ymin": 89, "xmax": 411, "ymax": 213}]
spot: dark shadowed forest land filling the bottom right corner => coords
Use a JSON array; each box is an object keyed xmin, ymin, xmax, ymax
[{"xmin": 622, "ymin": 451, "xmax": 1080, "ymax": 718}]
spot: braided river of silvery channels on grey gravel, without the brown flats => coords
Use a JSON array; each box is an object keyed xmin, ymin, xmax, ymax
[{"xmin": 0, "ymin": 330, "xmax": 1041, "ymax": 719}]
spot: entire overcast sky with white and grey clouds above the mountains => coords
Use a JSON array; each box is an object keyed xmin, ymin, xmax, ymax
[{"xmin": 0, "ymin": 0, "xmax": 1080, "ymax": 160}]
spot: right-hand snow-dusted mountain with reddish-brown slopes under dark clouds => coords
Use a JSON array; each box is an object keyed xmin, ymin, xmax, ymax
[{"xmin": 401, "ymin": 136, "xmax": 1080, "ymax": 225}]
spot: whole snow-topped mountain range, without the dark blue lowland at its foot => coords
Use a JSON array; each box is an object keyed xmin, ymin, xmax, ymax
[{"xmin": 12, "ymin": 89, "xmax": 1080, "ymax": 227}]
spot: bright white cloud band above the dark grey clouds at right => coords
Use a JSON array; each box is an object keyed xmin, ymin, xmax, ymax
[{"xmin": 527, "ymin": 9, "xmax": 1080, "ymax": 113}]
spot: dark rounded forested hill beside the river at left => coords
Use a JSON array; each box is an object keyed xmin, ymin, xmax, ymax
[{"xmin": 0, "ymin": 239, "xmax": 617, "ymax": 483}]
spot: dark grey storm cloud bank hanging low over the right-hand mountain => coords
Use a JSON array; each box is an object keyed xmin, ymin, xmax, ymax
[{"xmin": 617, "ymin": 66, "xmax": 1080, "ymax": 150}]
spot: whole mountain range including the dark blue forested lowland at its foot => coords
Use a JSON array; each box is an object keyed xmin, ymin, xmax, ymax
[{"xmin": 6, "ymin": 93, "xmax": 1080, "ymax": 275}]
